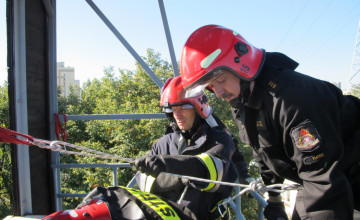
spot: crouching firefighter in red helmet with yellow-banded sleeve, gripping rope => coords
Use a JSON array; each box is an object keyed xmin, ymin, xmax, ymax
[{"xmin": 135, "ymin": 76, "xmax": 237, "ymax": 219}]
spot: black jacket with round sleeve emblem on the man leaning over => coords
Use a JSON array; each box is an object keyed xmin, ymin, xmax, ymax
[{"xmin": 231, "ymin": 53, "xmax": 360, "ymax": 219}]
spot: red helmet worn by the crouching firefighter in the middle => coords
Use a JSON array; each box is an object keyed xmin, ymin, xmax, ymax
[{"xmin": 160, "ymin": 76, "xmax": 211, "ymax": 118}]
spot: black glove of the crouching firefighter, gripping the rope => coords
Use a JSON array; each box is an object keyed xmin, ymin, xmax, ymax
[{"xmin": 134, "ymin": 155, "xmax": 166, "ymax": 177}]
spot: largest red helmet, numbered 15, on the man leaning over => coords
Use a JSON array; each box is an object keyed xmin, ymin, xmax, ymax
[{"xmin": 180, "ymin": 25, "xmax": 265, "ymax": 90}]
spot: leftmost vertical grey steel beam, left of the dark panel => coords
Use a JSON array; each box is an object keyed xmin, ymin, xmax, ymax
[{"xmin": 13, "ymin": 0, "xmax": 32, "ymax": 216}]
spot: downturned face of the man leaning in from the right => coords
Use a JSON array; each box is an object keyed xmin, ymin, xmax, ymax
[{"xmin": 209, "ymin": 70, "xmax": 240, "ymax": 102}]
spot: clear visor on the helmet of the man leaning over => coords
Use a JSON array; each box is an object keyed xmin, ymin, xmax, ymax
[{"xmin": 185, "ymin": 70, "xmax": 223, "ymax": 98}]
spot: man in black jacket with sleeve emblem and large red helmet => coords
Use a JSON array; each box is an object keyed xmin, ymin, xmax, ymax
[{"xmin": 180, "ymin": 25, "xmax": 360, "ymax": 219}]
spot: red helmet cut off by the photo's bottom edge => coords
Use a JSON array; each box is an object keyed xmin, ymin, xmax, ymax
[{"xmin": 42, "ymin": 199, "xmax": 111, "ymax": 220}]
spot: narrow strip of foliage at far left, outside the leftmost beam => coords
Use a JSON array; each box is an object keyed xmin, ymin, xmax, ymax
[{"xmin": 0, "ymin": 82, "xmax": 12, "ymax": 219}]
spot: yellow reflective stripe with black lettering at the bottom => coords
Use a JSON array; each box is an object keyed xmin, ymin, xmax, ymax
[{"xmin": 120, "ymin": 186, "xmax": 181, "ymax": 220}]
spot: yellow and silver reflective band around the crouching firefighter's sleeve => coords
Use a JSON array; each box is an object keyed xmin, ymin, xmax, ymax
[{"xmin": 196, "ymin": 153, "xmax": 224, "ymax": 192}]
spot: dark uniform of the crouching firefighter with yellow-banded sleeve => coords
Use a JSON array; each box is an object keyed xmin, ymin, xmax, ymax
[{"xmin": 136, "ymin": 123, "xmax": 237, "ymax": 219}]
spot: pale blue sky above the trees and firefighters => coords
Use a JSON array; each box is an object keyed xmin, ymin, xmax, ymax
[{"xmin": 0, "ymin": 0, "xmax": 360, "ymax": 90}]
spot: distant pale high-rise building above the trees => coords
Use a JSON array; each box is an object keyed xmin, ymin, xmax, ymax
[{"xmin": 56, "ymin": 62, "xmax": 80, "ymax": 96}]
